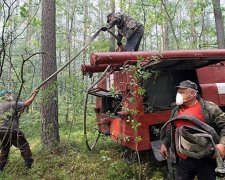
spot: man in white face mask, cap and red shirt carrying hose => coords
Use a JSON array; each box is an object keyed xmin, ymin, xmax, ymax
[{"xmin": 160, "ymin": 80, "xmax": 225, "ymax": 180}]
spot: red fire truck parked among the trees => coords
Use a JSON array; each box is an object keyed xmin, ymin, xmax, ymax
[{"xmin": 82, "ymin": 50, "xmax": 225, "ymax": 162}]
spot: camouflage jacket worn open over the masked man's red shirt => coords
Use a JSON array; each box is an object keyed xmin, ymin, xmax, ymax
[{"xmin": 160, "ymin": 97, "xmax": 225, "ymax": 161}]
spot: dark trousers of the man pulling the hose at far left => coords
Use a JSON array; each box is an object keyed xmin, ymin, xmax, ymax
[{"xmin": 0, "ymin": 129, "xmax": 33, "ymax": 166}]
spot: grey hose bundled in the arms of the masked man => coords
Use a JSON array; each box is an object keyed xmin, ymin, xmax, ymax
[{"xmin": 161, "ymin": 116, "xmax": 225, "ymax": 176}]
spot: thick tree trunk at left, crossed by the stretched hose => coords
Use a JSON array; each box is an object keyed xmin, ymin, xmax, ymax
[{"xmin": 41, "ymin": 0, "xmax": 60, "ymax": 149}]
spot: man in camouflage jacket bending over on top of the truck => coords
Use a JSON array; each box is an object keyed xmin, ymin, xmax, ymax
[{"xmin": 101, "ymin": 12, "xmax": 144, "ymax": 51}]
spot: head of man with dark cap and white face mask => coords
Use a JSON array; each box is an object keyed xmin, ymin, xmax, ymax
[{"xmin": 176, "ymin": 80, "xmax": 198, "ymax": 105}]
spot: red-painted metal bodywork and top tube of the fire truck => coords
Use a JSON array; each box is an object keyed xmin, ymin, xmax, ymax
[{"xmin": 88, "ymin": 50, "xmax": 225, "ymax": 151}]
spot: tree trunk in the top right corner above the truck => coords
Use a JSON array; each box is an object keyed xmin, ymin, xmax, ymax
[{"xmin": 212, "ymin": 0, "xmax": 225, "ymax": 49}]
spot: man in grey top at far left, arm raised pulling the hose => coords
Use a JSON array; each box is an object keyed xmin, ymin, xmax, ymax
[{"xmin": 0, "ymin": 89, "xmax": 38, "ymax": 171}]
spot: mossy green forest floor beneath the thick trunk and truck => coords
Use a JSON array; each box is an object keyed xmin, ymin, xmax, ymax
[{"xmin": 0, "ymin": 112, "xmax": 170, "ymax": 180}]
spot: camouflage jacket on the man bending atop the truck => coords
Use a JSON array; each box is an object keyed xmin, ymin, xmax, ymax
[{"xmin": 107, "ymin": 12, "xmax": 143, "ymax": 40}]
